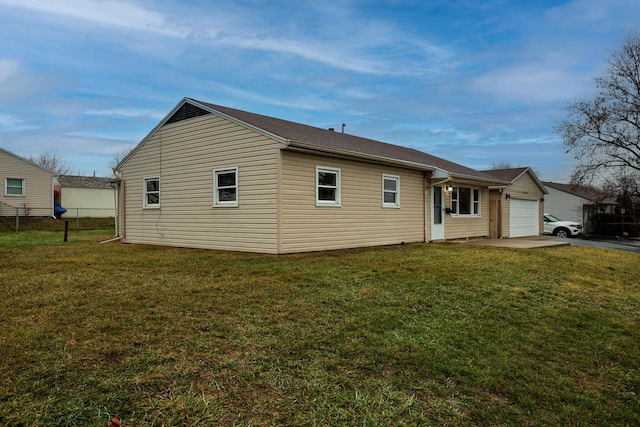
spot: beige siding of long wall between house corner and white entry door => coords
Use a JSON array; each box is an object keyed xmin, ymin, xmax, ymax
[{"xmin": 280, "ymin": 151, "xmax": 425, "ymax": 253}]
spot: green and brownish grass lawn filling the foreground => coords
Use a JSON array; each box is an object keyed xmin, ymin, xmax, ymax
[{"xmin": 0, "ymin": 230, "xmax": 640, "ymax": 426}]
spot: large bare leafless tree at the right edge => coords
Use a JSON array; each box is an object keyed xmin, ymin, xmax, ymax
[{"xmin": 556, "ymin": 31, "xmax": 640, "ymax": 196}]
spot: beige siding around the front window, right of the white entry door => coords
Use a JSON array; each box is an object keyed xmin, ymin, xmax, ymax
[{"xmin": 444, "ymin": 188, "xmax": 489, "ymax": 240}]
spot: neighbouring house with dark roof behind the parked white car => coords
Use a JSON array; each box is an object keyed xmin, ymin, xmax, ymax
[{"xmin": 543, "ymin": 181, "xmax": 617, "ymax": 233}]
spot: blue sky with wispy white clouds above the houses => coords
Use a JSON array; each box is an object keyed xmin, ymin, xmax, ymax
[{"xmin": 0, "ymin": 0, "xmax": 640, "ymax": 182}]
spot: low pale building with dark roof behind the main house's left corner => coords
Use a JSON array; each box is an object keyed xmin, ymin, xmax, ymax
[{"xmin": 58, "ymin": 175, "xmax": 116, "ymax": 218}]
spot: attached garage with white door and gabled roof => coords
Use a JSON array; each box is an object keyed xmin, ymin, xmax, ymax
[{"xmin": 484, "ymin": 167, "xmax": 547, "ymax": 238}]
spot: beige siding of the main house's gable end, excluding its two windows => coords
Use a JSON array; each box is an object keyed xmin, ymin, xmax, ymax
[{"xmin": 121, "ymin": 114, "xmax": 281, "ymax": 253}]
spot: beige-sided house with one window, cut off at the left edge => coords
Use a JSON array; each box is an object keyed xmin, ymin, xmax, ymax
[{"xmin": 0, "ymin": 148, "xmax": 55, "ymax": 221}]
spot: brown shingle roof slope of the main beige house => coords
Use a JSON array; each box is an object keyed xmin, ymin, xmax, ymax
[{"xmin": 190, "ymin": 98, "xmax": 504, "ymax": 182}]
